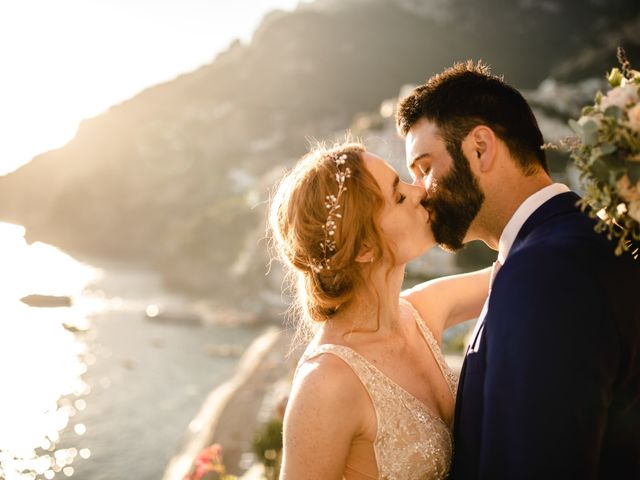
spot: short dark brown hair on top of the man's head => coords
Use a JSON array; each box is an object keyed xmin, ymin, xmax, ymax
[{"xmin": 396, "ymin": 60, "xmax": 548, "ymax": 175}]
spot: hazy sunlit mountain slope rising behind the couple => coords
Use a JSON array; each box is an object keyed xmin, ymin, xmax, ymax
[{"xmin": 0, "ymin": 0, "xmax": 640, "ymax": 318}]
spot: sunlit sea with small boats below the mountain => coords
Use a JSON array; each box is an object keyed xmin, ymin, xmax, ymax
[{"xmin": 0, "ymin": 223, "xmax": 264, "ymax": 480}]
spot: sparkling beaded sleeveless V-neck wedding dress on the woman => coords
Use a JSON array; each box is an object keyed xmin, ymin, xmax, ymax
[{"xmin": 300, "ymin": 299, "xmax": 457, "ymax": 480}]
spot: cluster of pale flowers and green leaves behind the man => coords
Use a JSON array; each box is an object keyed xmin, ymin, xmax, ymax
[{"xmin": 563, "ymin": 48, "xmax": 640, "ymax": 259}]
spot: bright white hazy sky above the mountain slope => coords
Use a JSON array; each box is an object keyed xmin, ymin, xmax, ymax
[{"xmin": 0, "ymin": 0, "xmax": 308, "ymax": 175}]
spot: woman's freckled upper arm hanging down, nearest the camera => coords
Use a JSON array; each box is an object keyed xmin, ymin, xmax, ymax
[{"xmin": 280, "ymin": 354, "xmax": 362, "ymax": 480}]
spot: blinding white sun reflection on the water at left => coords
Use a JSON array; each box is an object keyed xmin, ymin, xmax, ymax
[{"xmin": 0, "ymin": 223, "xmax": 100, "ymax": 480}]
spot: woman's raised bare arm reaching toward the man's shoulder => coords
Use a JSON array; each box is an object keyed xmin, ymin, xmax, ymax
[{"xmin": 401, "ymin": 267, "xmax": 491, "ymax": 336}]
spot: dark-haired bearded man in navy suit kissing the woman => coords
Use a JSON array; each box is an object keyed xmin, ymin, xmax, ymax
[{"xmin": 396, "ymin": 62, "xmax": 640, "ymax": 480}]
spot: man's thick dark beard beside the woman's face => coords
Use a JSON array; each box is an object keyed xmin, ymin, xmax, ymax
[{"xmin": 426, "ymin": 146, "xmax": 484, "ymax": 252}]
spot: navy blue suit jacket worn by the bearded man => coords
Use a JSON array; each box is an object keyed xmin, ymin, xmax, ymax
[{"xmin": 450, "ymin": 192, "xmax": 640, "ymax": 480}]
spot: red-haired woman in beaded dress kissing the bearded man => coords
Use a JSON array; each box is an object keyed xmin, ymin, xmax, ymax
[{"xmin": 270, "ymin": 143, "xmax": 489, "ymax": 480}]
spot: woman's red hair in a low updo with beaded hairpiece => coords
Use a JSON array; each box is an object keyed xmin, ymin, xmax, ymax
[{"xmin": 269, "ymin": 143, "xmax": 386, "ymax": 322}]
